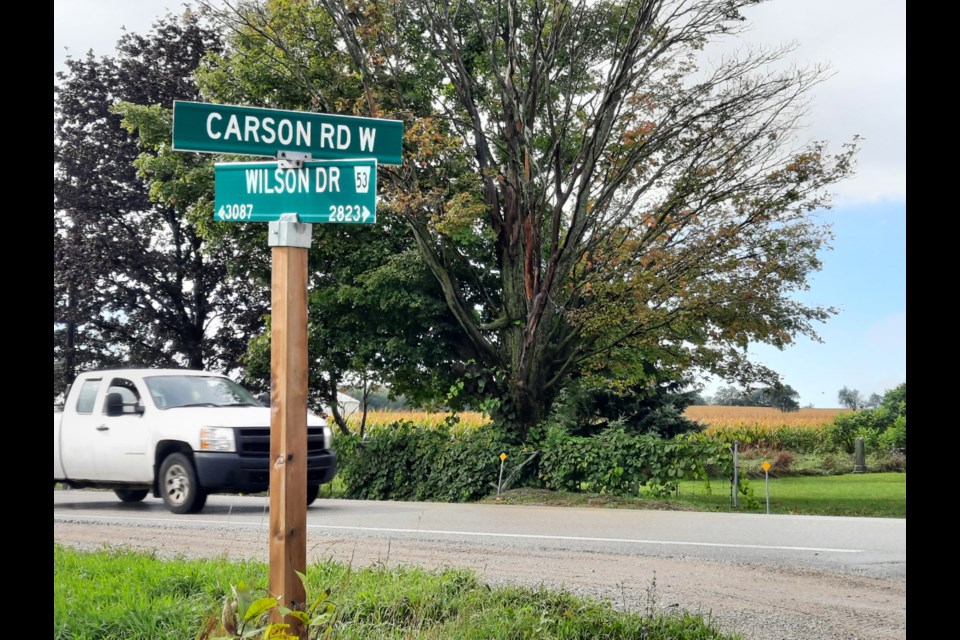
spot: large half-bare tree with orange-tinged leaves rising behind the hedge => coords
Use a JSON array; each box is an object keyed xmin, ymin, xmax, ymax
[{"xmin": 195, "ymin": 0, "xmax": 855, "ymax": 434}]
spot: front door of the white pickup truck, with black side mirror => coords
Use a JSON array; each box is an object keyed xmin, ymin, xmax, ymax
[{"xmin": 95, "ymin": 377, "xmax": 153, "ymax": 482}]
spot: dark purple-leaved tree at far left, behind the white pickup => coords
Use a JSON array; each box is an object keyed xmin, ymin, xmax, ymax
[{"xmin": 53, "ymin": 12, "xmax": 269, "ymax": 396}]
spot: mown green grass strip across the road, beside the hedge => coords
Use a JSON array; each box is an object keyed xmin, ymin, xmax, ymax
[{"xmin": 484, "ymin": 473, "xmax": 907, "ymax": 518}]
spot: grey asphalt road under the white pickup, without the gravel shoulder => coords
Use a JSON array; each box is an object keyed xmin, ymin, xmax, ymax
[{"xmin": 54, "ymin": 491, "xmax": 907, "ymax": 578}]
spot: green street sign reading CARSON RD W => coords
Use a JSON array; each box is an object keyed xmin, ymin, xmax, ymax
[{"xmin": 173, "ymin": 100, "xmax": 403, "ymax": 164}]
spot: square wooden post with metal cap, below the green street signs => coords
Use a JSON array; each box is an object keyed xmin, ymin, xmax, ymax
[{"xmin": 269, "ymin": 216, "xmax": 312, "ymax": 639}]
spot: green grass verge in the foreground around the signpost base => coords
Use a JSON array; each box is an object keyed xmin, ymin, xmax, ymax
[{"xmin": 53, "ymin": 544, "xmax": 739, "ymax": 640}]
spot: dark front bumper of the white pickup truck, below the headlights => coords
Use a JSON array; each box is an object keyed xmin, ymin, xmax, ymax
[{"xmin": 193, "ymin": 451, "xmax": 337, "ymax": 493}]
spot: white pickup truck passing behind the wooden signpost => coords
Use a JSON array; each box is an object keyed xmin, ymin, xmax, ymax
[{"xmin": 53, "ymin": 369, "xmax": 337, "ymax": 513}]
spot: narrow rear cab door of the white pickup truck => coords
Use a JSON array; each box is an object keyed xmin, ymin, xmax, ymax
[{"xmin": 60, "ymin": 378, "xmax": 103, "ymax": 480}]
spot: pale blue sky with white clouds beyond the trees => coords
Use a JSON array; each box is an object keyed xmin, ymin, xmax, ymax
[{"xmin": 53, "ymin": 0, "xmax": 907, "ymax": 408}]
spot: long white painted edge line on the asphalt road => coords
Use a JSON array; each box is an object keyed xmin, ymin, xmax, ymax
[{"xmin": 53, "ymin": 511, "xmax": 864, "ymax": 553}]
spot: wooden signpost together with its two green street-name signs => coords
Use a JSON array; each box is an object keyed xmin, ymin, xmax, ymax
[{"xmin": 173, "ymin": 100, "xmax": 403, "ymax": 639}]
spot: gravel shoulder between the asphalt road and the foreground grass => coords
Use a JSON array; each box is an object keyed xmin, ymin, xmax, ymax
[{"xmin": 54, "ymin": 522, "xmax": 907, "ymax": 640}]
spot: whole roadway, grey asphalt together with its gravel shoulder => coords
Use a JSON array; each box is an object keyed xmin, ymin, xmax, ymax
[{"xmin": 54, "ymin": 490, "xmax": 906, "ymax": 640}]
